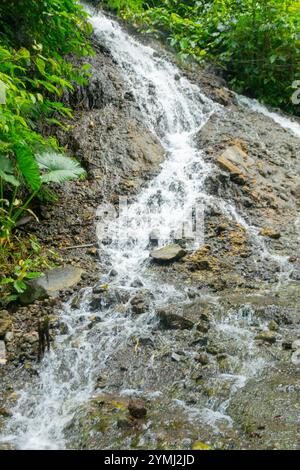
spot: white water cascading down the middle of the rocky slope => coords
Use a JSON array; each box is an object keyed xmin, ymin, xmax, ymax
[{"xmin": 2, "ymin": 9, "xmax": 298, "ymax": 449}]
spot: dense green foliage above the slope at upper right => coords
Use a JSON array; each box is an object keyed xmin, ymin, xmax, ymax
[{"xmin": 102, "ymin": 0, "xmax": 300, "ymax": 115}]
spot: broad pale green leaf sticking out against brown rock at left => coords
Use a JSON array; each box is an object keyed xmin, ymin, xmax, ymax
[{"xmin": 36, "ymin": 153, "xmax": 85, "ymax": 183}]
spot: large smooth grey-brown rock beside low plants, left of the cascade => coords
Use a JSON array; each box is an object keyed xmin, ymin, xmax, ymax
[{"xmin": 20, "ymin": 266, "xmax": 84, "ymax": 305}]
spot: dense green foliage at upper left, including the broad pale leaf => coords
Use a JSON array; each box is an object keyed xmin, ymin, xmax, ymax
[{"xmin": 0, "ymin": 0, "xmax": 92, "ymax": 241}]
